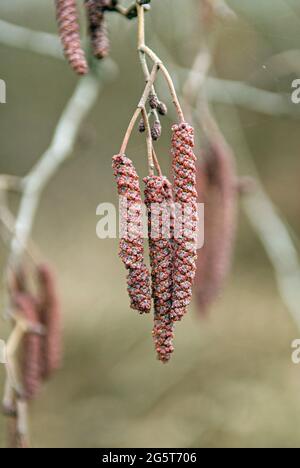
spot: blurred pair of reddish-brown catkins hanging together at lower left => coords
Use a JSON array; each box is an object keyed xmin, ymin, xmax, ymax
[{"xmin": 10, "ymin": 264, "xmax": 62, "ymax": 400}]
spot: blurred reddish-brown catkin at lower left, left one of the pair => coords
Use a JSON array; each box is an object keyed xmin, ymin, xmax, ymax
[{"xmin": 13, "ymin": 293, "xmax": 41, "ymax": 400}]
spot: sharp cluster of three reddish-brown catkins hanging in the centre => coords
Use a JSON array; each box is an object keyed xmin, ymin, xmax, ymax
[{"xmin": 113, "ymin": 123, "xmax": 197, "ymax": 363}]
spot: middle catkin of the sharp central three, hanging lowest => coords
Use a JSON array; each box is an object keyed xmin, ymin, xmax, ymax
[{"xmin": 144, "ymin": 176, "xmax": 174, "ymax": 363}]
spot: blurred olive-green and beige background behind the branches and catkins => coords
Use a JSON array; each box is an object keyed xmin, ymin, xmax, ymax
[{"xmin": 0, "ymin": 0, "xmax": 300, "ymax": 448}]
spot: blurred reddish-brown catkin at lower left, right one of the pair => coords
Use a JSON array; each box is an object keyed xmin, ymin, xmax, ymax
[{"xmin": 37, "ymin": 264, "xmax": 62, "ymax": 378}]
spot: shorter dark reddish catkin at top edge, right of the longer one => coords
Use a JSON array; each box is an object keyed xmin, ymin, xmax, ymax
[{"xmin": 85, "ymin": 0, "xmax": 109, "ymax": 59}]
